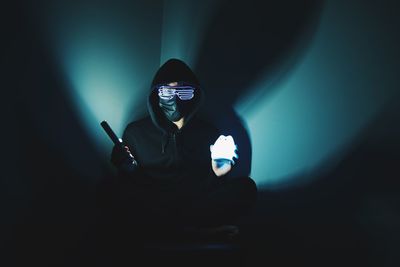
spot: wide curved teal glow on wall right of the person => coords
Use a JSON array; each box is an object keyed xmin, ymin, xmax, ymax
[{"xmin": 236, "ymin": 1, "xmax": 397, "ymax": 188}]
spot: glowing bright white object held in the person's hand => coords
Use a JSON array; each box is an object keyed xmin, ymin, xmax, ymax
[{"xmin": 210, "ymin": 135, "xmax": 238, "ymax": 164}]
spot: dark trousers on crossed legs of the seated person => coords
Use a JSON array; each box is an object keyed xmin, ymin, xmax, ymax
[{"xmin": 96, "ymin": 177, "xmax": 257, "ymax": 245}]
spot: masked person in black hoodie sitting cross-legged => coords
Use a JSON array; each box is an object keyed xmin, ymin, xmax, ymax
[{"xmin": 111, "ymin": 59, "xmax": 257, "ymax": 241}]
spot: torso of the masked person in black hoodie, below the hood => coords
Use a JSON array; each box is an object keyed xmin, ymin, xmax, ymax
[{"xmin": 123, "ymin": 118, "xmax": 218, "ymax": 188}]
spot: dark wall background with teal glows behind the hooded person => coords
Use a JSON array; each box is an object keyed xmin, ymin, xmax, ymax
[{"xmin": 1, "ymin": 0, "xmax": 400, "ymax": 266}]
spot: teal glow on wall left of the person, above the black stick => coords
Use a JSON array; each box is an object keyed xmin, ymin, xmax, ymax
[{"xmin": 43, "ymin": 1, "xmax": 162, "ymax": 156}]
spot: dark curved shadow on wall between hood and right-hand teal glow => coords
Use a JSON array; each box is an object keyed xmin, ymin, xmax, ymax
[{"xmin": 194, "ymin": 0, "xmax": 322, "ymax": 180}]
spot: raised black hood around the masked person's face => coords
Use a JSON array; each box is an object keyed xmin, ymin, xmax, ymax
[{"xmin": 148, "ymin": 59, "xmax": 204, "ymax": 133}]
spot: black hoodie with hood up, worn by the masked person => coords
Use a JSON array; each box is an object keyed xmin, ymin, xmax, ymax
[{"xmin": 115, "ymin": 59, "xmax": 219, "ymax": 199}]
